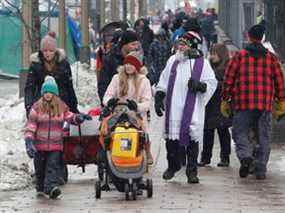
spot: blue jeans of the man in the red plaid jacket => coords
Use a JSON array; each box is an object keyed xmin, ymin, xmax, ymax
[{"xmin": 233, "ymin": 110, "xmax": 272, "ymax": 173}]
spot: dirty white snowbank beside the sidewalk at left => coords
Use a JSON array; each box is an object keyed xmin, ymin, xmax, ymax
[{"xmin": 0, "ymin": 63, "xmax": 99, "ymax": 191}]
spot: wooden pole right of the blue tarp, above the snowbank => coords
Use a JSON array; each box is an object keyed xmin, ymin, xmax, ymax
[{"xmin": 80, "ymin": 0, "xmax": 90, "ymax": 64}]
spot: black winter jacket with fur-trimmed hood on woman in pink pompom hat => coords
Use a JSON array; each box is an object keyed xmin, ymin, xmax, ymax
[{"xmin": 25, "ymin": 49, "xmax": 78, "ymax": 115}]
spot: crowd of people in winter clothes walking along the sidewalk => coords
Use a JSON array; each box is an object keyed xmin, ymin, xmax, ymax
[{"xmin": 22, "ymin": 6, "xmax": 285, "ymax": 198}]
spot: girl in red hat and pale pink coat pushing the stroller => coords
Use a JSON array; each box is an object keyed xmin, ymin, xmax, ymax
[{"xmin": 103, "ymin": 52, "xmax": 153, "ymax": 164}]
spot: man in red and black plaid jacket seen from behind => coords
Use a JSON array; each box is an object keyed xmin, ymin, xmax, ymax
[{"xmin": 221, "ymin": 25, "xmax": 285, "ymax": 179}]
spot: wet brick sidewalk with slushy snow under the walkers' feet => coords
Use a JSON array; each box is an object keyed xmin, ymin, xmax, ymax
[{"xmin": 0, "ymin": 110, "xmax": 285, "ymax": 213}]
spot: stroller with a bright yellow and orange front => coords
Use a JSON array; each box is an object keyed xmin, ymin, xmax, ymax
[{"xmin": 95, "ymin": 104, "xmax": 153, "ymax": 200}]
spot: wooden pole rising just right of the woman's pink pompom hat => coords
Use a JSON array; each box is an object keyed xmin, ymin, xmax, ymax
[{"xmin": 58, "ymin": 0, "xmax": 66, "ymax": 50}]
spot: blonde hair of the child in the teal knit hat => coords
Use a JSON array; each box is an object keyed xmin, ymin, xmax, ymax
[{"xmin": 38, "ymin": 95, "xmax": 67, "ymax": 117}]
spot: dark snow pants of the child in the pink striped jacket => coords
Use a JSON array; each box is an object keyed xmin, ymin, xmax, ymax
[{"xmin": 34, "ymin": 151, "xmax": 61, "ymax": 194}]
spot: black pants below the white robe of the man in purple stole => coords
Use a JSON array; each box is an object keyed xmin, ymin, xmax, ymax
[{"xmin": 166, "ymin": 140, "xmax": 199, "ymax": 173}]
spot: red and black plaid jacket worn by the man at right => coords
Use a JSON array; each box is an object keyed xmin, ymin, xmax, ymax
[{"xmin": 222, "ymin": 50, "xmax": 285, "ymax": 111}]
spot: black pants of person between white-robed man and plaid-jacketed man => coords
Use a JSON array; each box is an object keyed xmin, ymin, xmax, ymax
[{"xmin": 201, "ymin": 128, "xmax": 231, "ymax": 162}]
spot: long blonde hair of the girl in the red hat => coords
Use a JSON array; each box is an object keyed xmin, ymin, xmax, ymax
[{"xmin": 118, "ymin": 65, "xmax": 147, "ymax": 98}]
